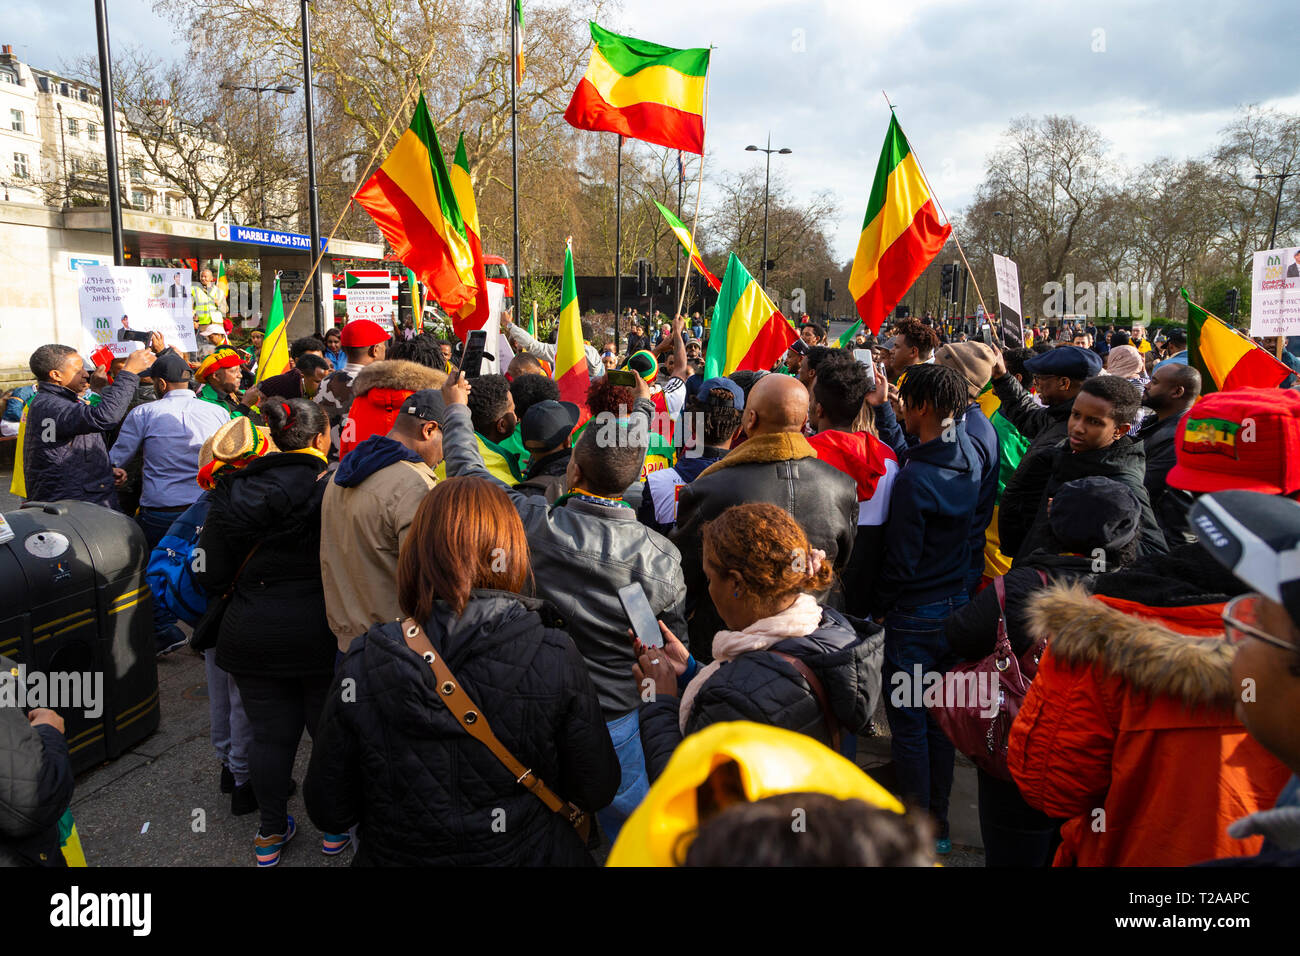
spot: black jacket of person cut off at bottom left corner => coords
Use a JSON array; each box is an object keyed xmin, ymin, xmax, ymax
[{"xmin": 0, "ymin": 657, "xmax": 73, "ymax": 866}]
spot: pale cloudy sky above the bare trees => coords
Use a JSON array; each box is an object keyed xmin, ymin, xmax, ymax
[{"xmin": 10, "ymin": 0, "xmax": 1300, "ymax": 259}]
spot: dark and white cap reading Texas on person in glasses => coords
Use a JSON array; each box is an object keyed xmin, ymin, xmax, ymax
[{"xmin": 1187, "ymin": 492, "xmax": 1300, "ymax": 628}]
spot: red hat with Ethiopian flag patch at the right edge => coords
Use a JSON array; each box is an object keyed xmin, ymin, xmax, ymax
[{"xmin": 1166, "ymin": 389, "xmax": 1300, "ymax": 494}]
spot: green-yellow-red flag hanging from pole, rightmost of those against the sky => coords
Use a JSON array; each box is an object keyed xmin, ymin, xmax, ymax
[{"xmin": 849, "ymin": 116, "xmax": 953, "ymax": 334}]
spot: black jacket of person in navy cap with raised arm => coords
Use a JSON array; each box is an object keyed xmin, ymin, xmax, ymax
[{"xmin": 993, "ymin": 375, "xmax": 1074, "ymax": 555}]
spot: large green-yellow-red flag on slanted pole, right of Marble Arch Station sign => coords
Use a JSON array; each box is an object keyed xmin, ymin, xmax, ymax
[{"xmin": 352, "ymin": 92, "xmax": 477, "ymax": 312}]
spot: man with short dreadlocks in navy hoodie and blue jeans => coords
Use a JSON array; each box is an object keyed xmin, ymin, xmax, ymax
[{"xmin": 874, "ymin": 364, "xmax": 980, "ymax": 853}]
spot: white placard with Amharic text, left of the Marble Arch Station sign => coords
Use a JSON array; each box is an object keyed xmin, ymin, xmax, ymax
[{"xmin": 77, "ymin": 265, "xmax": 198, "ymax": 358}]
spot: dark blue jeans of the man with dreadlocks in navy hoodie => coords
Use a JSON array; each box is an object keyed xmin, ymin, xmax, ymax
[{"xmin": 883, "ymin": 591, "xmax": 967, "ymax": 839}]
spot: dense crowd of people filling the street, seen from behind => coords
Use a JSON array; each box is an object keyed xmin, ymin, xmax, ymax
[{"xmin": 0, "ymin": 300, "xmax": 1300, "ymax": 868}]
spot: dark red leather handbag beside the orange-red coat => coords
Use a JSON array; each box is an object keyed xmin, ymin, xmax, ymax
[{"xmin": 930, "ymin": 570, "xmax": 1048, "ymax": 780}]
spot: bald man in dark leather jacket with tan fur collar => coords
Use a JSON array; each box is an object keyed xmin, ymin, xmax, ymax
[{"xmin": 672, "ymin": 375, "xmax": 858, "ymax": 661}]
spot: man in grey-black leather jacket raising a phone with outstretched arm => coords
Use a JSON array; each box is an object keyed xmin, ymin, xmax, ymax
[{"xmin": 442, "ymin": 376, "xmax": 686, "ymax": 843}]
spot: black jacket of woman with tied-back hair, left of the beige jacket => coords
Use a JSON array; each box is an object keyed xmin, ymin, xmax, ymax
[{"xmin": 195, "ymin": 453, "xmax": 338, "ymax": 676}]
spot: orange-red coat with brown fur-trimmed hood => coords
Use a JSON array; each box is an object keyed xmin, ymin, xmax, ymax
[{"xmin": 1008, "ymin": 585, "xmax": 1288, "ymax": 866}]
